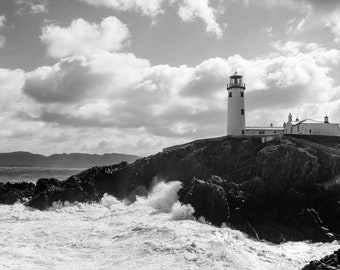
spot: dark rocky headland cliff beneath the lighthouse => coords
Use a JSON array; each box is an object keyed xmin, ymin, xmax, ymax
[{"xmin": 1, "ymin": 137, "xmax": 340, "ymax": 243}]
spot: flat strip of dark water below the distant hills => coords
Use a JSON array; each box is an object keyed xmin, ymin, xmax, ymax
[{"xmin": 0, "ymin": 167, "xmax": 84, "ymax": 183}]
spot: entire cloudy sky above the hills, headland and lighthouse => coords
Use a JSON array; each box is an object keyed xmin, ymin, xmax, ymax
[{"xmin": 0, "ymin": 0, "xmax": 340, "ymax": 156}]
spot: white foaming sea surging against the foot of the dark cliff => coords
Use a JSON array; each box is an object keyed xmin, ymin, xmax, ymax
[{"xmin": 0, "ymin": 172, "xmax": 340, "ymax": 270}]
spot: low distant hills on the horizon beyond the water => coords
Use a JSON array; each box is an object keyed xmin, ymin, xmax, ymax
[{"xmin": 0, "ymin": 152, "xmax": 140, "ymax": 168}]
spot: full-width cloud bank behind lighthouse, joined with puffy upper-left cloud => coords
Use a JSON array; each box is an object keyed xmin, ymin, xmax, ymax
[{"xmin": 0, "ymin": 17, "xmax": 332, "ymax": 154}]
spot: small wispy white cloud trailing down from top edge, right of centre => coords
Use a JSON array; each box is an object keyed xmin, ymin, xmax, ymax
[{"xmin": 178, "ymin": 0, "xmax": 223, "ymax": 38}]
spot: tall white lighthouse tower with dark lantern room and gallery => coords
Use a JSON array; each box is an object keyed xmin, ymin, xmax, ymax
[{"xmin": 227, "ymin": 72, "xmax": 246, "ymax": 135}]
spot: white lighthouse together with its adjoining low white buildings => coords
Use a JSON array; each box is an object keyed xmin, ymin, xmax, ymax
[{"xmin": 227, "ymin": 72, "xmax": 340, "ymax": 136}]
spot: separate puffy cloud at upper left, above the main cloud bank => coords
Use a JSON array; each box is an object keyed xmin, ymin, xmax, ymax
[{"xmin": 40, "ymin": 16, "xmax": 130, "ymax": 58}]
